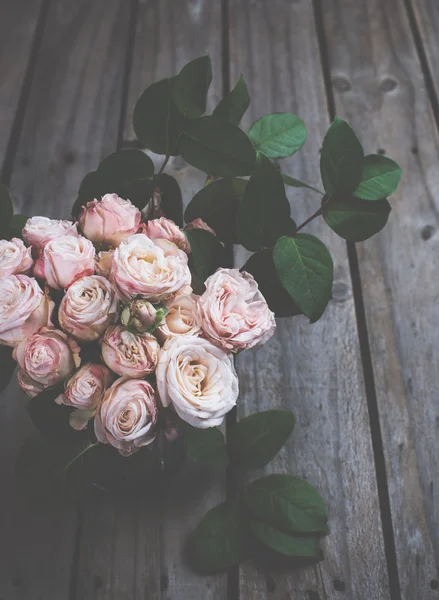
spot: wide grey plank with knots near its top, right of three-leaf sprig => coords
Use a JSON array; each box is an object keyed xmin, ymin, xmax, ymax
[{"xmin": 321, "ymin": 0, "xmax": 439, "ymax": 600}]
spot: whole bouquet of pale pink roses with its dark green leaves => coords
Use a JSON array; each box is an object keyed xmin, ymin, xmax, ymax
[{"xmin": 0, "ymin": 57, "xmax": 400, "ymax": 571}]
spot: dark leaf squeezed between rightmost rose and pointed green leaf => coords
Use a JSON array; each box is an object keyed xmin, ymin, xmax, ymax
[{"xmin": 241, "ymin": 249, "xmax": 300, "ymax": 317}]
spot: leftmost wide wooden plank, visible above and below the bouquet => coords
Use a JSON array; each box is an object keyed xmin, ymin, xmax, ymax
[{"xmin": 0, "ymin": 0, "xmax": 129, "ymax": 600}]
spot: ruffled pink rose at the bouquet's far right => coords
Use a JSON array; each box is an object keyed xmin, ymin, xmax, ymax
[{"xmin": 199, "ymin": 269, "xmax": 276, "ymax": 352}]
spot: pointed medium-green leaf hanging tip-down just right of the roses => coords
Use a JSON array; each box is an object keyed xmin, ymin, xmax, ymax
[{"xmin": 273, "ymin": 233, "xmax": 334, "ymax": 323}]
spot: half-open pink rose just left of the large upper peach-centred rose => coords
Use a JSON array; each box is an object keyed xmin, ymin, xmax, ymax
[{"xmin": 34, "ymin": 235, "xmax": 95, "ymax": 290}]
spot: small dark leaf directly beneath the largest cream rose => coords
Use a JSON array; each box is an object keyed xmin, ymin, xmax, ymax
[{"xmin": 184, "ymin": 423, "xmax": 227, "ymax": 465}]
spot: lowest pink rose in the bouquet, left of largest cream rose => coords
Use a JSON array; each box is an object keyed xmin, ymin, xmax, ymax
[{"xmin": 95, "ymin": 377, "xmax": 158, "ymax": 456}]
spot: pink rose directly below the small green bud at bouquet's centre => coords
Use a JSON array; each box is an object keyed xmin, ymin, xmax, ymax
[{"xmin": 102, "ymin": 325, "xmax": 160, "ymax": 377}]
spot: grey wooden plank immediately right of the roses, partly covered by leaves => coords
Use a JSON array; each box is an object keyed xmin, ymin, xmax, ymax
[{"xmin": 230, "ymin": 0, "xmax": 389, "ymax": 600}]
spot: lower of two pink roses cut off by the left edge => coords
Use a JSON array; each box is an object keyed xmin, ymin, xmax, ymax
[{"xmin": 0, "ymin": 275, "xmax": 55, "ymax": 346}]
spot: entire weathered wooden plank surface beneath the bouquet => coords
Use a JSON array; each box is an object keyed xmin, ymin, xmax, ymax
[{"xmin": 0, "ymin": 0, "xmax": 439, "ymax": 600}]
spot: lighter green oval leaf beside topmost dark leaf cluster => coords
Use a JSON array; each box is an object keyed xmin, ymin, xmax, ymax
[{"xmin": 248, "ymin": 113, "xmax": 306, "ymax": 158}]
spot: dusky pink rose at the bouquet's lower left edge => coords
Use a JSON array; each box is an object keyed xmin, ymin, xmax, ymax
[{"xmin": 13, "ymin": 327, "xmax": 81, "ymax": 397}]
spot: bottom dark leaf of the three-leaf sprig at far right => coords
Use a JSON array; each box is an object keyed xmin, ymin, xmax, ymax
[{"xmin": 322, "ymin": 198, "xmax": 391, "ymax": 242}]
